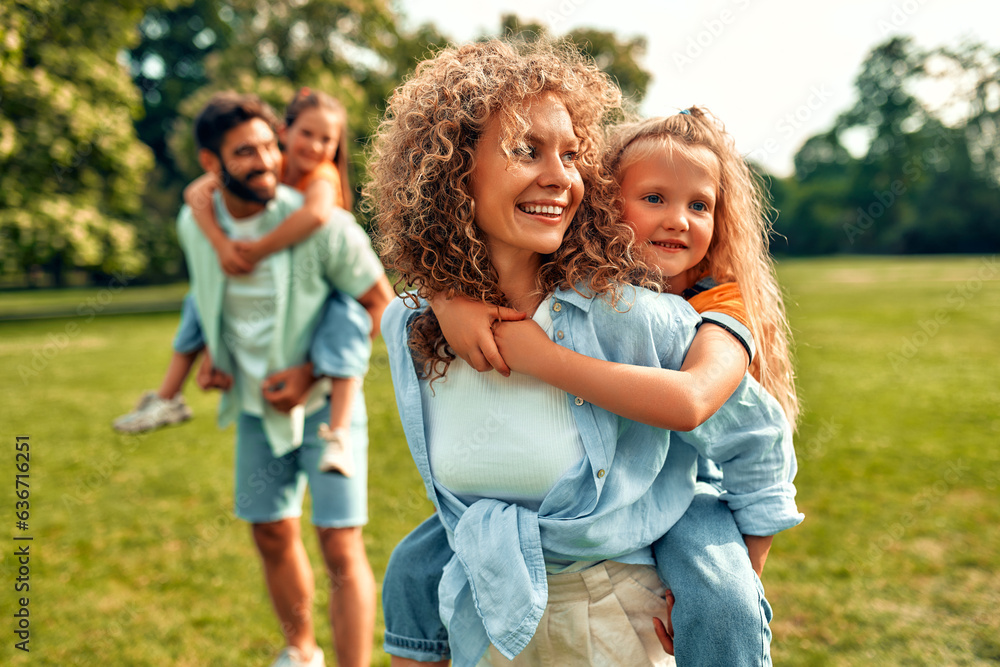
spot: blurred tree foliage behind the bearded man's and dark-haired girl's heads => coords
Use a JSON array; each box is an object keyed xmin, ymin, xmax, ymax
[{"xmin": 168, "ymin": 0, "xmax": 446, "ymax": 182}]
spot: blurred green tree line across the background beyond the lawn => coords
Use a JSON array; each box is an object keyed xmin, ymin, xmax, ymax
[{"xmin": 0, "ymin": 0, "xmax": 1000, "ymax": 284}]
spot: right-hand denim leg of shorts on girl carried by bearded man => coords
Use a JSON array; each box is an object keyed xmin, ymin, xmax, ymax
[{"xmin": 309, "ymin": 290, "xmax": 372, "ymax": 378}]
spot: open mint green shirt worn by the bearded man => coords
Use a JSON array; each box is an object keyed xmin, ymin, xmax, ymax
[{"xmin": 177, "ymin": 185, "xmax": 384, "ymax": 456}]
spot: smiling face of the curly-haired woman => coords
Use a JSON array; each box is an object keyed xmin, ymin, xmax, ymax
[{"xmin": 470, "ymin": 93, "xmax": 583, "ymax": 264}]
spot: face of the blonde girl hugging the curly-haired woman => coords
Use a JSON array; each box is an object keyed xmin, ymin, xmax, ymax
[{"xmin": 621, "ymin": 146, "xmax": 719, "ymax": 294}]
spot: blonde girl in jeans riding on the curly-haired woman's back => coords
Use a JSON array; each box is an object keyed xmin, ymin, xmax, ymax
[{"xmin": 383, "ymin": 107, "xmax": 798, "ymax": 667}]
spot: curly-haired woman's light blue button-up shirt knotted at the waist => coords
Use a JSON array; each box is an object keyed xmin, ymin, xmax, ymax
[{"xmin": 382, "ymin": 288, "xmax": 803, "ymax": 667}]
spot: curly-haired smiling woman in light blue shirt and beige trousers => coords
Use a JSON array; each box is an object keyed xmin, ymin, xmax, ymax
[{"xmin": 366, "ymin": 40, "xmax": 794, "ymax": 667}]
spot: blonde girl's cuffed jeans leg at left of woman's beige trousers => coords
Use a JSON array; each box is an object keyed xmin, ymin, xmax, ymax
[{"xmin": 382, "ymin": 514, "xmax": 453, "ymax": 662}]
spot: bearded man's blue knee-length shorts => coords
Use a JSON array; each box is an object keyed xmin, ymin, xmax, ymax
[{"xmin": 235, "ymin": 402, "xmax": 368, "ymax": 528}]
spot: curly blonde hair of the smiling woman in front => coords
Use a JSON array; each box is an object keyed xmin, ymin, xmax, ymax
[{"xmin": 362, "ymin": 39, "xmax": 646, "ymax": 379}]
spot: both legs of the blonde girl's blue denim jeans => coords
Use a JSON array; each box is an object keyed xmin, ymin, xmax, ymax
[{"xmin": 382, "ymin": 482, "xmax": 771, "ymax": 667}]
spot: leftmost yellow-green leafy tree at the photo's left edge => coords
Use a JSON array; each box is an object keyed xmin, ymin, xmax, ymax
[{"xmin": 0, "ymin": 0, "xmax": 172, "ymax": 282}]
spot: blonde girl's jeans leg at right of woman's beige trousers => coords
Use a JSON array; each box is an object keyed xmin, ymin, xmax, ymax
[{"xmin": 653, "ymin": 483, "xmax": 771, "ymax": 667}]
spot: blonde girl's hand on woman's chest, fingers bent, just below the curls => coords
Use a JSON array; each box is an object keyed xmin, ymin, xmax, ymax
[{"xmin": 430, "ymin": 294, "xmax": 527, "ymax": 377}]
